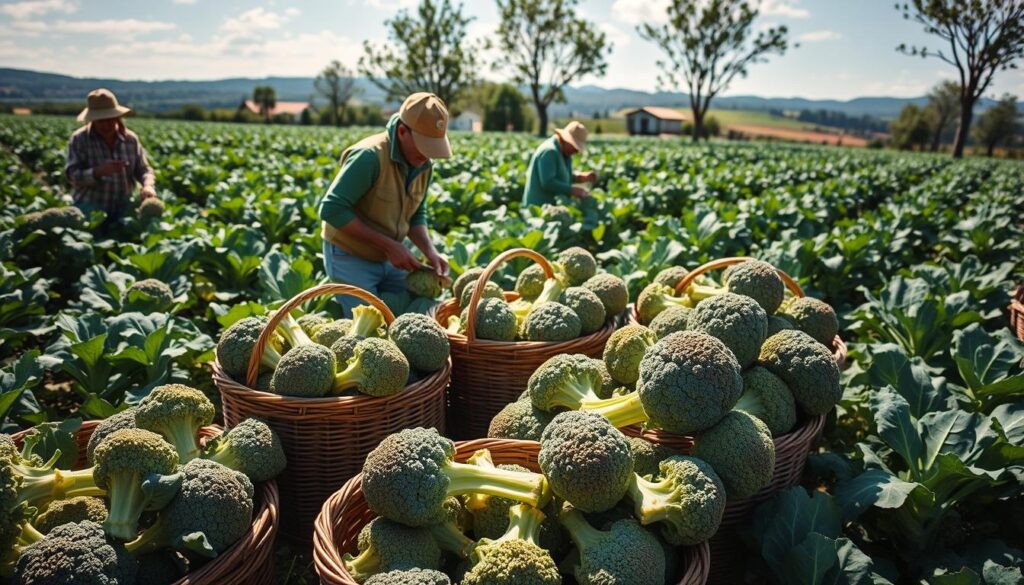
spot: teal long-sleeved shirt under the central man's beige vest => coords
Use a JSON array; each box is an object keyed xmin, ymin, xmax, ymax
[{"xmin": 319, "ymin": 114, "xmax": 430, "ymax": 228}]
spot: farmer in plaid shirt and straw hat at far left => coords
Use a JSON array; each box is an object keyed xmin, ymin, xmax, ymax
[{"xmin": 65, "ymin": 89, "xmax": 157, "ymax": 226}]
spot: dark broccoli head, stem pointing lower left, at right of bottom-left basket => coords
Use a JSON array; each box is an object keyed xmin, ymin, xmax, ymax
[{"xmin": 125, "ymin": 459, "xmax": 254, "ymax": 558}]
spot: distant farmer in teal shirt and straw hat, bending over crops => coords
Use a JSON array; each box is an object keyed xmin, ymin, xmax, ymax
[{"xmin": 522, "ymin": 121, "xmax": 597, "ymax": 205}]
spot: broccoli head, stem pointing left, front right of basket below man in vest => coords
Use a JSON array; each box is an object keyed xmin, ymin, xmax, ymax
[{"xmin": 334, "ymin": 337, "xmax": 409, "ymax": 396}]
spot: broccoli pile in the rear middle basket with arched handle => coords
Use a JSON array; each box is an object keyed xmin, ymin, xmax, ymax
[{"xmin": 445, "ymin": 246, "xmax": 629, "ymax": 342}]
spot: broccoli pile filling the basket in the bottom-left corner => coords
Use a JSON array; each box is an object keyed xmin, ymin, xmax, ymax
[{"xmin": 0, "ymin": 384, "xmax": 287, "ymax": 585}]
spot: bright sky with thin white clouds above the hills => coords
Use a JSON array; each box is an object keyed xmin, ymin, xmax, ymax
[{"xmin": 0, "ymin": 0, "xmax": 1024, "ymax": 99}]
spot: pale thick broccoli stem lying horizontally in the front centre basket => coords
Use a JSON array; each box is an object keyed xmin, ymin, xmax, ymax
[{"xmin": 444, "ymin": 461, "xmax": 549, "ymax": 507}]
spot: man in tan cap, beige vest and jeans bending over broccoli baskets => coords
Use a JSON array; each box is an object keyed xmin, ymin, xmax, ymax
[{"xmin": 319, "ymin": 92, "xmax": 452, "ymax": 316}]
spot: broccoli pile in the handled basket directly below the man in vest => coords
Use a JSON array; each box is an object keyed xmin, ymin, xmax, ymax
[{"xmin": 216, "ymin": 306, "xmax": 450, "ymax": 398}]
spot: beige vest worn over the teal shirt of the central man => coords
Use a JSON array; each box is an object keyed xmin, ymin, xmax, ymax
[{"xmin": 321, "ymin": 132, "xmax": 430, "ymax": 262}]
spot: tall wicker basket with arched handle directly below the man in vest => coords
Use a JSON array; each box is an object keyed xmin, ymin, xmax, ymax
[{"xmin": 213, "ymin": 284, "xmax": 452, "ymax": 543}]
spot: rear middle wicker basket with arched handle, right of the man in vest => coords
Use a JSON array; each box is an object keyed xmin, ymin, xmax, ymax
[{"xmin": 435, "ymin": 248, "xmax": 615, "ymax": 440}]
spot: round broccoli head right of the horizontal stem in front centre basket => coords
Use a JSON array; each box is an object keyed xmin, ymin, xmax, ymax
[{"xmin": 538, "ymin": 411, "xmax": 633, "ymax": 512}]
